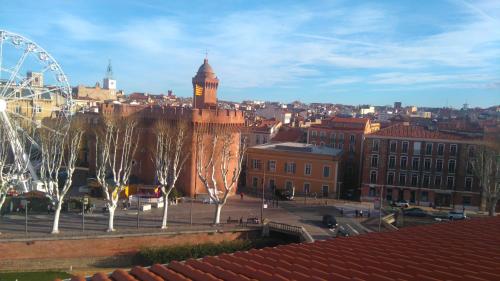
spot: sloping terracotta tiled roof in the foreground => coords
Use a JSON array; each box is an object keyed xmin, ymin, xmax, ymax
[{"xmin": 64, "ymin": 217, "xmax": 500, "ymax": 281}]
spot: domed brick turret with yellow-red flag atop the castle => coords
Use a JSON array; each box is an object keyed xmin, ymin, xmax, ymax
[{"xmin": 193, "ymin": 58, "xmax": 219, "ymax": 109}]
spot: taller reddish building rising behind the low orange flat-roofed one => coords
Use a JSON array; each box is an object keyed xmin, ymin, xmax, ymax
[{"xmin": 307, "ymin": 117, "xmax": 378, "ymax": 199}]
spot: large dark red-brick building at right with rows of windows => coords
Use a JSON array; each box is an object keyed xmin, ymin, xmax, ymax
[{"xmin": 361, "ymin": 123, "xmax": 481, "ymax": 208}]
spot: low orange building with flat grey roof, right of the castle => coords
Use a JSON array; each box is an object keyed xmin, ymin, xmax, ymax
[{"xmin": 246, "ymin": 142, "xmax": 341, "ymax": 198}]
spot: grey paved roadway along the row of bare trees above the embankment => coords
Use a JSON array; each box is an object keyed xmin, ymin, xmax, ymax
[{"xmin": 0, "ymin": 191, "xmax": 376, "ymax": 239}]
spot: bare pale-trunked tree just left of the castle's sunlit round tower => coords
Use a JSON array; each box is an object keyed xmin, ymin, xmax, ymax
[{"xmin": 153, "ymin": 120, "xmax": 189, "ymax": 229}]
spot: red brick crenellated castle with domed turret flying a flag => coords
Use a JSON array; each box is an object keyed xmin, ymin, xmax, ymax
[{"xmin": 84, "ymin": 59, "xmax": 244, "ymax": 196}]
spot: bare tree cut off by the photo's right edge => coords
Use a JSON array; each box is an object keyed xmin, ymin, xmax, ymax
[{"xmin": 471, "ymin": 143, "xmax": 500, "ymax": 216}]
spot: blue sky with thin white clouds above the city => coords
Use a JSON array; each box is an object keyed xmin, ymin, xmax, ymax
[{"xmin": 0, "ymin": 0, "xmax": 500, "ymax": 108}]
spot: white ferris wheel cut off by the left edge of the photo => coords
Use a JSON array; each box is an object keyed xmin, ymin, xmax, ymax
[{"xmin": 0, "ymin": 29, "xmax": 72, "ymax": 192}]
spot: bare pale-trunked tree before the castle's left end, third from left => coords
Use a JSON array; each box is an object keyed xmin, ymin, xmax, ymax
[{"xmin": 95, "ymin": 118, "xmax": 139, "ymax": 232}]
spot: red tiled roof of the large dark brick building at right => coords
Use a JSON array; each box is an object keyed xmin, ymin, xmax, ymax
[{"xmin": 367, "ymin": 123, "xmax": 473, "ymax": 140}]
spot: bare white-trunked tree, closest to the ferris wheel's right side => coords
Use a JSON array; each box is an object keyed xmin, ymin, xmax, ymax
[{"xmin": 40, "ymin": 118, "xmax": 83, "ymax": 234}]
